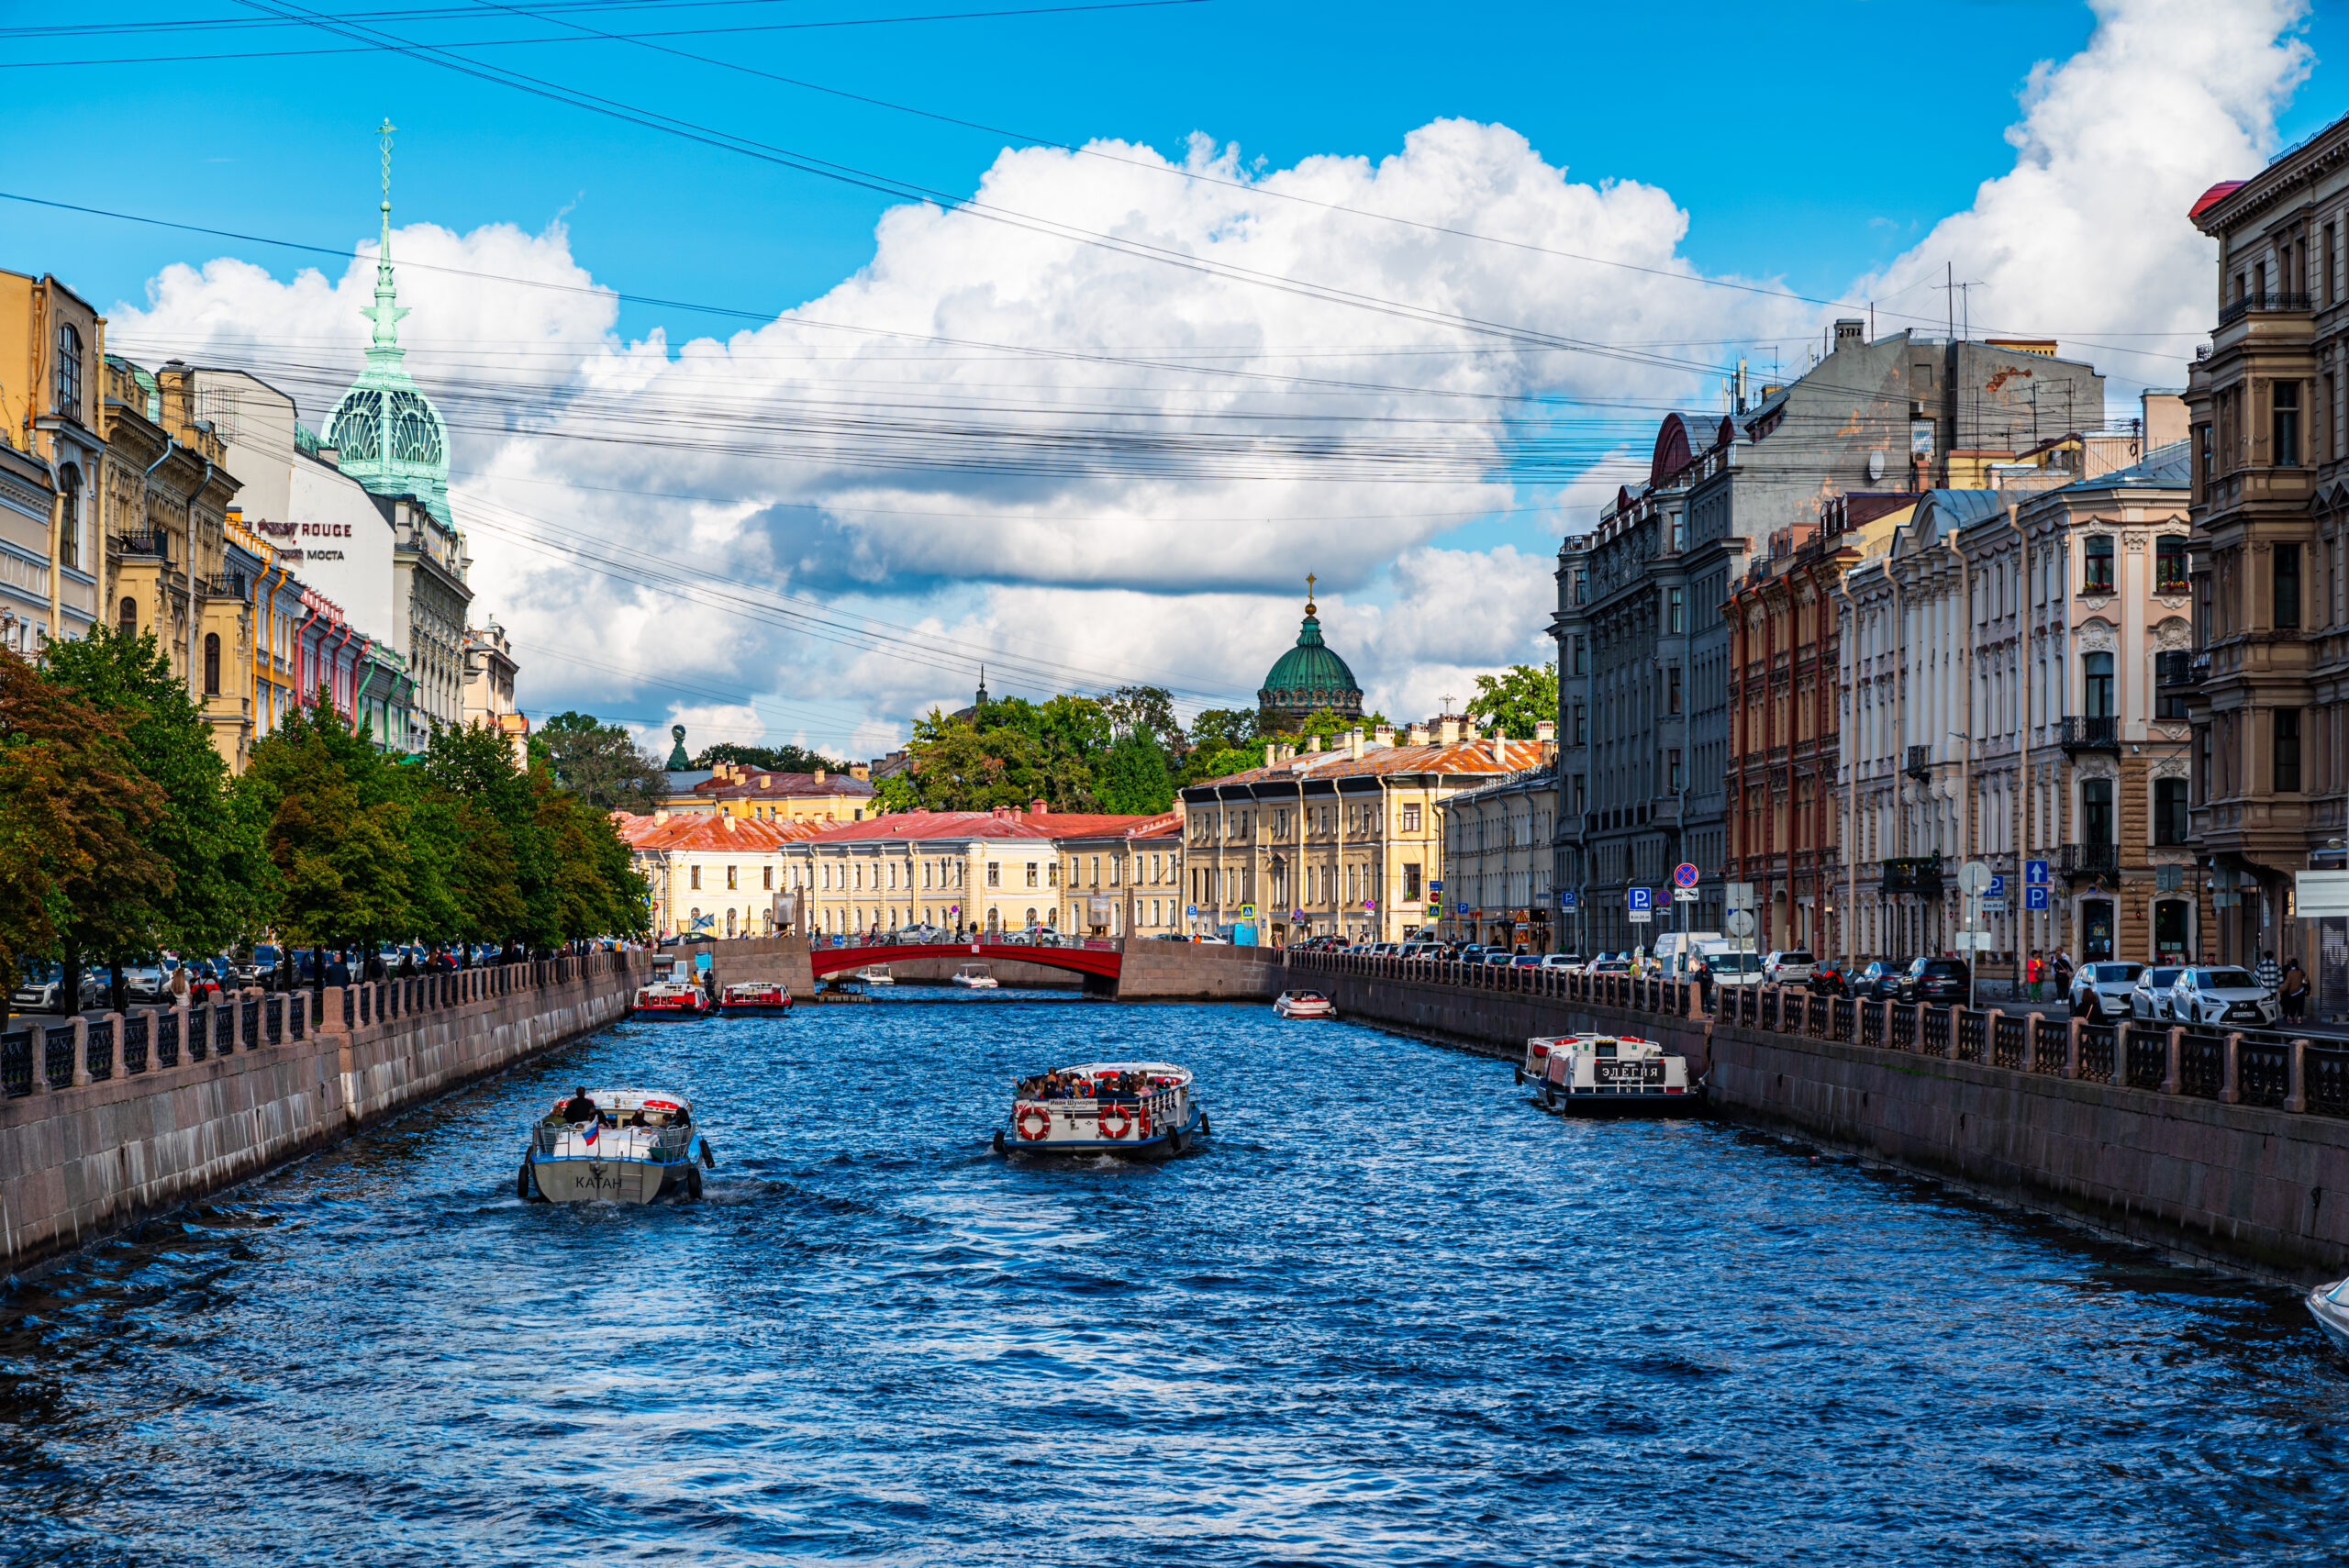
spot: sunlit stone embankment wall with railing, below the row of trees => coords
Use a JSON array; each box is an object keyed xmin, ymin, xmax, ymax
[{"xmin": 0, "ymin": 953, "xmax": 646, "ymax": 1273}]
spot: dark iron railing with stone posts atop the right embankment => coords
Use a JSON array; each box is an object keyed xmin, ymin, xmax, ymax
[{"xmin": 1283, "ymin": 949, "xmax": 2349, "ymax": 1118}]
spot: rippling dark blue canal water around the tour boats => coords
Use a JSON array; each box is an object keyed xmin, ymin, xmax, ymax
[{"xmin": 0, "ymin": 991, "xmax": 2349, "ymax": 1568}]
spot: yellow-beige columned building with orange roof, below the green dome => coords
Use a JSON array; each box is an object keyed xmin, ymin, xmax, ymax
[{"xmin": 1182, "ymin": 716, "xmax": 1555, "ymax": 946}]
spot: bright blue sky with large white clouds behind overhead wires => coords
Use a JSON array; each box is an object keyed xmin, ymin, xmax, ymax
[{"xmin": 0, "ymin": 0, "xmax": 2344, "ymax": 749}]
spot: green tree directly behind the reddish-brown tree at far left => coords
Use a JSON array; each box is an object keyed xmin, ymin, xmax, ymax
[{"xmin": 42, "ymin": 627, "xmax": 245, "ymax": 1007}]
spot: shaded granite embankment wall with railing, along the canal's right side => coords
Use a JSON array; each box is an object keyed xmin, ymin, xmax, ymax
[{"xmin": 1289, "ymin": 953, "xmax": 2349, "ymax": 1284}]
